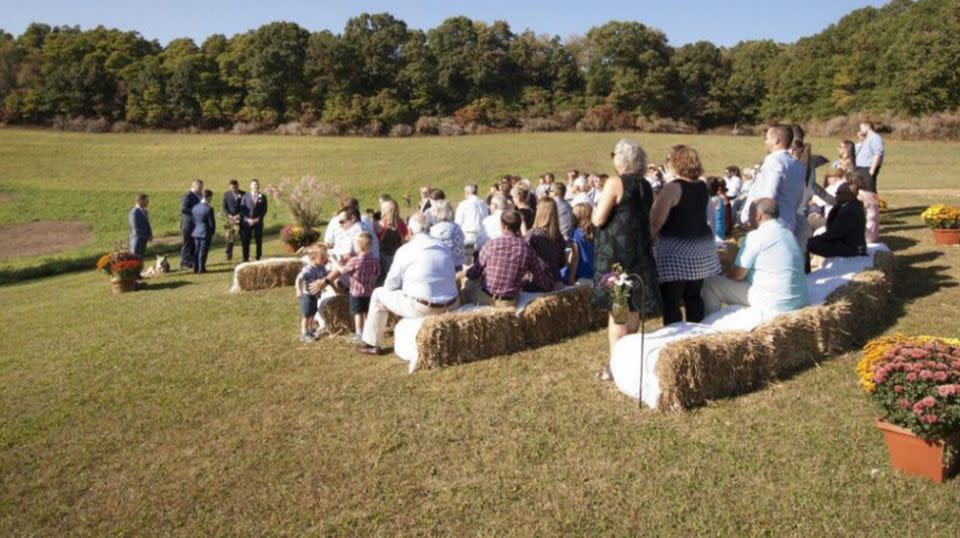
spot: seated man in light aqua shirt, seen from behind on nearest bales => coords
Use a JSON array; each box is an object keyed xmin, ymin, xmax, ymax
[{"xmin": 703, "ymin": 198, "xmax": 807, "ymax": 314}]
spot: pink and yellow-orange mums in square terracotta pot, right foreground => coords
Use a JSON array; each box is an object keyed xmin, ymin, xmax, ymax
[{"xmin": 857, "ymin": 334, "xmax": 960, "ymax": 482}]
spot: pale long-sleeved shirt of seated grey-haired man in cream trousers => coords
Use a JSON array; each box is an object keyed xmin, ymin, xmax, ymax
[{"xmin": 383, "ymin": 233, "xmax": 458, "ymax": 304}]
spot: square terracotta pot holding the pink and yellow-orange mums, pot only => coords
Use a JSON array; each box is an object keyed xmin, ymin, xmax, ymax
[{"xmin": 877, "ymin": 420, "xmax": 960, "ymax": 484}]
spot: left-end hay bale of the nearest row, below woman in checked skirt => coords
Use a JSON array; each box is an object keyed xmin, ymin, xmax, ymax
[{"xmin": 656, "ymin": 331, "xmax": 774, "ymax": 411}]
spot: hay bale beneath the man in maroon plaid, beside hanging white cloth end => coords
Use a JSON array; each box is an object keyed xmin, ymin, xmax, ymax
[{"xmin": 417, "ymin": 308, "xmax": 525, "ymax": 368}]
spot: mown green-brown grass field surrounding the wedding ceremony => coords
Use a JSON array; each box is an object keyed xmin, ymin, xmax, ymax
[{"xmin": 0, "ymin": 130, "xmax": 960, "ymax": 536}]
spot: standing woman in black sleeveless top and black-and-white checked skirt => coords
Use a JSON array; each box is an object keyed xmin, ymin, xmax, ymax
[{"xmin": 650, "ymin": 145, "xmax": 720, "ymax": 325}]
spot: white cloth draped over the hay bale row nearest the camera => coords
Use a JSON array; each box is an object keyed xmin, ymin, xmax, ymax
[{"xmin": 610, "ymin": 244, "xmax": 890, "ymax": 408}]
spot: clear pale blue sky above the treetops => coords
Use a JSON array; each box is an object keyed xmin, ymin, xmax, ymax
[{"xmin": 0, "ymin": 0, "xmax": 884, "ymax": 45}]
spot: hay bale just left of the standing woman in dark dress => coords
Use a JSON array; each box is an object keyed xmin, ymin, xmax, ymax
[{"xmin": 519, "ymin": 286, "xmax": 606, "ymax": 347}]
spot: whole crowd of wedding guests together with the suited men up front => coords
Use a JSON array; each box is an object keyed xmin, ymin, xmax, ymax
[{"xmin": 130, "ymin": 122, "xmax": 883, "ymax": 354}]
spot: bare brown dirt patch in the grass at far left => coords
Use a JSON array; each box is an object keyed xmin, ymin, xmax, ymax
[{"xmin": 0, "ymin": 220, "xmax": 93, "ymax": 260}]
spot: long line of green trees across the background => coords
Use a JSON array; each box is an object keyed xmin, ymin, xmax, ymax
[{"xmin": 0, "ymin": 0, "xmax": 960, "ymax": 134}]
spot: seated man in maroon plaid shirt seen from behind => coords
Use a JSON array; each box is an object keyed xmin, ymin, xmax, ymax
[{"xmin": 463, "ymin": 211, "xmax": 553, "ymax": 308}]
